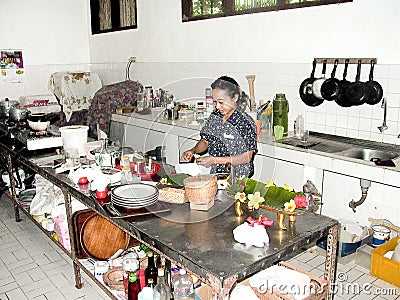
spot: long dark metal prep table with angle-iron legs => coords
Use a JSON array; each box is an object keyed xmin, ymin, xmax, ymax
[{"xmin": 0, "ymin": 139, "xmax": 338, "ymax": 299}]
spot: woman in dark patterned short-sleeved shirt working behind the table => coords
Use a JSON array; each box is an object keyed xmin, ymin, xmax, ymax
[{"xmin": 181, "ymin": 76, "xmax": 257, "ymax": 177}]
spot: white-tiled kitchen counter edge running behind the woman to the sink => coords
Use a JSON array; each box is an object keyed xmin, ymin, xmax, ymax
[{"xmin": 112, "ymin": 110, "xmax": 400, "ymax": 187}]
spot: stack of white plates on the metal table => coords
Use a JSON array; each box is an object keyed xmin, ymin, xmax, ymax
[{"xmin": 111, "ymin": 183, "xmax": 158, "ymax": 208}]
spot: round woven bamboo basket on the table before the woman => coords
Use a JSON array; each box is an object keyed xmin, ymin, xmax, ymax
[{"xmin": 183, "ymin": 174, "xmax": 218, "ymax": 204}]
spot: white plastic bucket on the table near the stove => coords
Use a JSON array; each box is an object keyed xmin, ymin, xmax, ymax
[{"xmin": 60, "ymin": 125, "xmax": 89, "ymax": 156}]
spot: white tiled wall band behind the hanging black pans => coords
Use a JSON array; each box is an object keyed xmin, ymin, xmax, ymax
[{"xmin": 0, "ymin": 59, "xmax": 400, "ymax": 145}]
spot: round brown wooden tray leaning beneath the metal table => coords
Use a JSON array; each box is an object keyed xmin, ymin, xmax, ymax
[{"xmin": 80, "ymin": 214, "xmax": 130, "ymax": 260}]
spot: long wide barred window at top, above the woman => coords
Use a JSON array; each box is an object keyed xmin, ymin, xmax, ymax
[{"xmin": 182, "ymin": 0, "xmax": 353, "ymax": 22}]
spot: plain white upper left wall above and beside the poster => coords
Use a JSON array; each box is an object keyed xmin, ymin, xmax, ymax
[{"xmin": 0, "ymin": 0, "xmax": 89, "ymax": 65}]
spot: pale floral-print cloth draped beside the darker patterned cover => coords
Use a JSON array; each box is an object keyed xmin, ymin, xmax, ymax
[{"xmin": 48, "ymin": 72, "xmax": 102, "ymax": 122}]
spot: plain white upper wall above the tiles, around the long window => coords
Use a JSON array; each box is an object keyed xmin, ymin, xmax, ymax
[{"xmin": 87, "ymin": 0, "xmax": 400, "ymax": 64}]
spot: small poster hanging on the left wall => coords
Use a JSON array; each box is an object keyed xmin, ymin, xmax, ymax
[{"xmin": 0, "ymin": 49, "xmax": 25, "ymax": 82}]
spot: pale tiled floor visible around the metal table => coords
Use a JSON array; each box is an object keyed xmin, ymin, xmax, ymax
[{"xmin": 0, "ymin": 196, "xmax": 400, "ymax": 300}]
